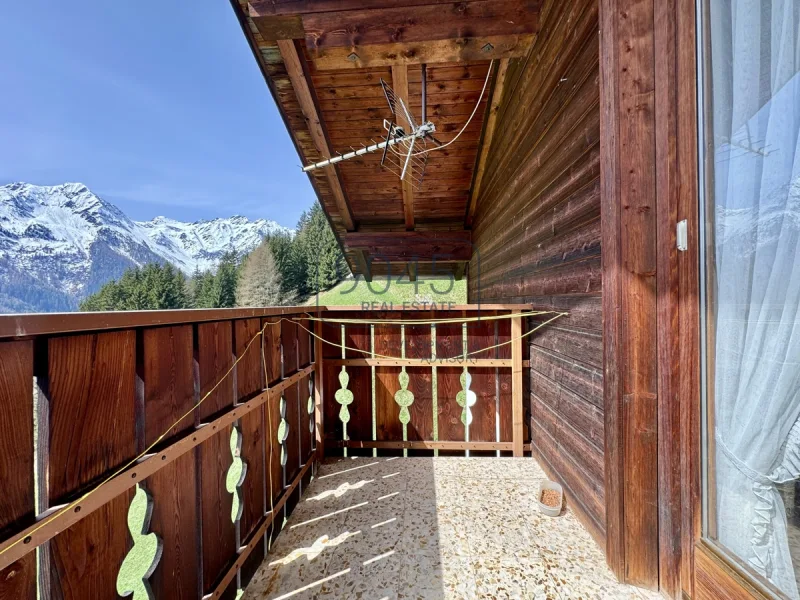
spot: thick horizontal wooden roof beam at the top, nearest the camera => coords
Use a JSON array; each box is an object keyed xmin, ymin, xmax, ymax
[{"xmin": 249, "ymin": 0, "xmax": 542, "ymax": 70}]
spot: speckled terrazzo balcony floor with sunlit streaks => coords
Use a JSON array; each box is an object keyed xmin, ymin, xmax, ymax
[{"xmin": 244, "ymin": 457, "xmax": 660, "ymax": 600}]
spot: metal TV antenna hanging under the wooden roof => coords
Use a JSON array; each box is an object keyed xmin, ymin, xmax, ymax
[{"xmin": 303, "ymin": 61, "xmax": 494, "ymax": 188}]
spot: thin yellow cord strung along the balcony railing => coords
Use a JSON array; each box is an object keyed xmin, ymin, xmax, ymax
[{"xmin": 0, "ymin": 311, "xmax": 569, "ymax": 556}]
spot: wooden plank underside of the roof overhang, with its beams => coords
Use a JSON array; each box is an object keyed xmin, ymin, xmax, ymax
[{"xmin": 234, "ymin": 0, "xmax": 541, "ymax": 275}]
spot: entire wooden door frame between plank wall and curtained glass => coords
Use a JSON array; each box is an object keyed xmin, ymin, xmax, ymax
[{"xmin": 600, "ymin": 0, "xmax": 701, "ymax": 598}]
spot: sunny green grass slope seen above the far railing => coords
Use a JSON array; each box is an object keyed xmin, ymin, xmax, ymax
[{"xmin": 307, "ymin": 277, "xmax": 467, "ymax": 309}]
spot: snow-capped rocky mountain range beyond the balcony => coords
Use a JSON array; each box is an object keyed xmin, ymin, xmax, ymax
[{"xmin": 0, "ymin": 183, "xmax": 291, "ymax": 312}]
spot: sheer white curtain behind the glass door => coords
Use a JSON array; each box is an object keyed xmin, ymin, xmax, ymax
[{"xmin": 709, "ymin": 0, "xmax": 800, "ymax": 599}]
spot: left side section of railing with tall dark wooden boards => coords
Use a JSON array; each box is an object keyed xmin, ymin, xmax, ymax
[{"xmin": 0, "ymin": 316, "xmax": 314, "ymax": 600}]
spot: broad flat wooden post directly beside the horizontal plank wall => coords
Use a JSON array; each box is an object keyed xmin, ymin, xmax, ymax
[{"xmin": 599, "ymin": 0, "xmax": 660, "ymax": 589}]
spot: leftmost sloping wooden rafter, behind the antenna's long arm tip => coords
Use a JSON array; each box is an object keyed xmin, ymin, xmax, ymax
[{"xmin": 278, "ymin": 40, "xmax": 355, "ymax": 231}]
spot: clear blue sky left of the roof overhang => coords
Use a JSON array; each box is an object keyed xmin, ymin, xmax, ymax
[{"xmin": 0, "ymin": 0, "xmax": 315, "ymax": 226}]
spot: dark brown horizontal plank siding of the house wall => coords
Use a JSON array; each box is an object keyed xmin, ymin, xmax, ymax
[{"xmin": 468, "ymin": 0, "xmax": 606, "ymax": 544}]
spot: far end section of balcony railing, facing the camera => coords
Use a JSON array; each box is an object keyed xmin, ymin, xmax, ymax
[{"xmin": 321, "ymin": 310, "xmax": 530, "ymax": 456}]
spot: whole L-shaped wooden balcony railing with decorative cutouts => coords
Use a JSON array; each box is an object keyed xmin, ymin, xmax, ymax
[{"xmin": 0, "ymin": 306, "xmax": 528, "ymax": 600}]
